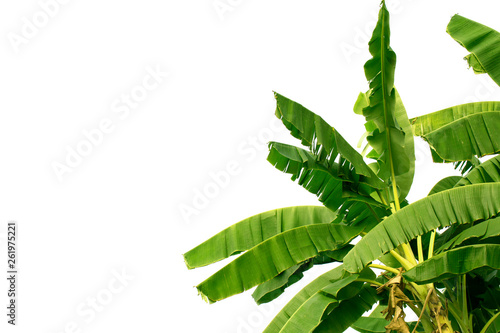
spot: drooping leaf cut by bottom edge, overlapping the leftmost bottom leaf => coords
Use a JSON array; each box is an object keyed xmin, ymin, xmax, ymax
[{"xmin": 281, "ymin": 270, "xmax": 375, "ymax": 333}]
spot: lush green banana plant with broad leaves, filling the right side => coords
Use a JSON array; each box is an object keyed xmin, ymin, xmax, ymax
[{"xmin": 184, "ymin": 1, "xmax": 500, "ymax": 333}]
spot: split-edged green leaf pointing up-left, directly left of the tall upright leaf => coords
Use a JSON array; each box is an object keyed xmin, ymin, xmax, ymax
[{"xmin": 274, "ymin": 93, "xmax": 384, "ymax": 188}]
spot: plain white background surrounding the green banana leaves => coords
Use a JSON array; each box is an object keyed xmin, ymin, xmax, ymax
[{"xmin": 0, "ymin": 0, "xmax": 500, "ymax": 333}]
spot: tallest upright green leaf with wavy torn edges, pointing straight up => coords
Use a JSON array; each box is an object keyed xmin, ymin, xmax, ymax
[{"xmin": 362, "ymin": 2, "xmax": 411, "ymax": 180}]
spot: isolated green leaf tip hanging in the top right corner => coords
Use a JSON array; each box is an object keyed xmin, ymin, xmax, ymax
[{"xmin": 446, "ymin": 15, "xmax": 500, "ymax": 85}]
